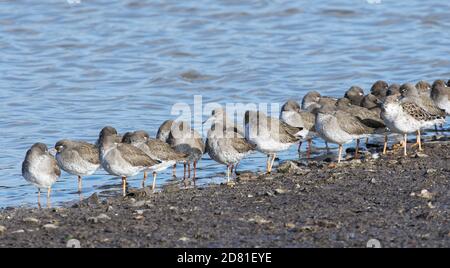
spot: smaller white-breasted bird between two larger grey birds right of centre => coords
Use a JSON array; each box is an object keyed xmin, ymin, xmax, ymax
[{"xmin": 280, "ymin": 100, "xmax": 316, "ymax": 158}]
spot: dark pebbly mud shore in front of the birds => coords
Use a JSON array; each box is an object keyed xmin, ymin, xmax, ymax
[{"xmin": 0, "ymin": 142, "xmax": 450, "ymax": 247}]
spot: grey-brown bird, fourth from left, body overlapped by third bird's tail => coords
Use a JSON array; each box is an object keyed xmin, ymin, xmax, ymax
[{"xmin": 122, "ymin": 130, "xmax": 188, "ymax": 190}]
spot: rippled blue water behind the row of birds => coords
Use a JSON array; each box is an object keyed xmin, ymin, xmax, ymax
[{"xmin": 0, "ymin": 0, "xmax": 450, "ymax": 207}]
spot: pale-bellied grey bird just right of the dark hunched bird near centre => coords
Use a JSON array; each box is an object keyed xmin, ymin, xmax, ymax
[{"xmin": 206, "ymin": 122, "xmax": 255, "ymax": 183}]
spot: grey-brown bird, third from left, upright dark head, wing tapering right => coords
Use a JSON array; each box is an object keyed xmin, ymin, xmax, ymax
[{"xmin": 99, "ymin": 126, "xmax": 160, "ymax": 196}]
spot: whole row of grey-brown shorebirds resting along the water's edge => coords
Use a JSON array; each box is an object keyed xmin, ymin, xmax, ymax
[{"xmin": 22, "ymin": 80, "xmax": 450, "ymax": 206}]
